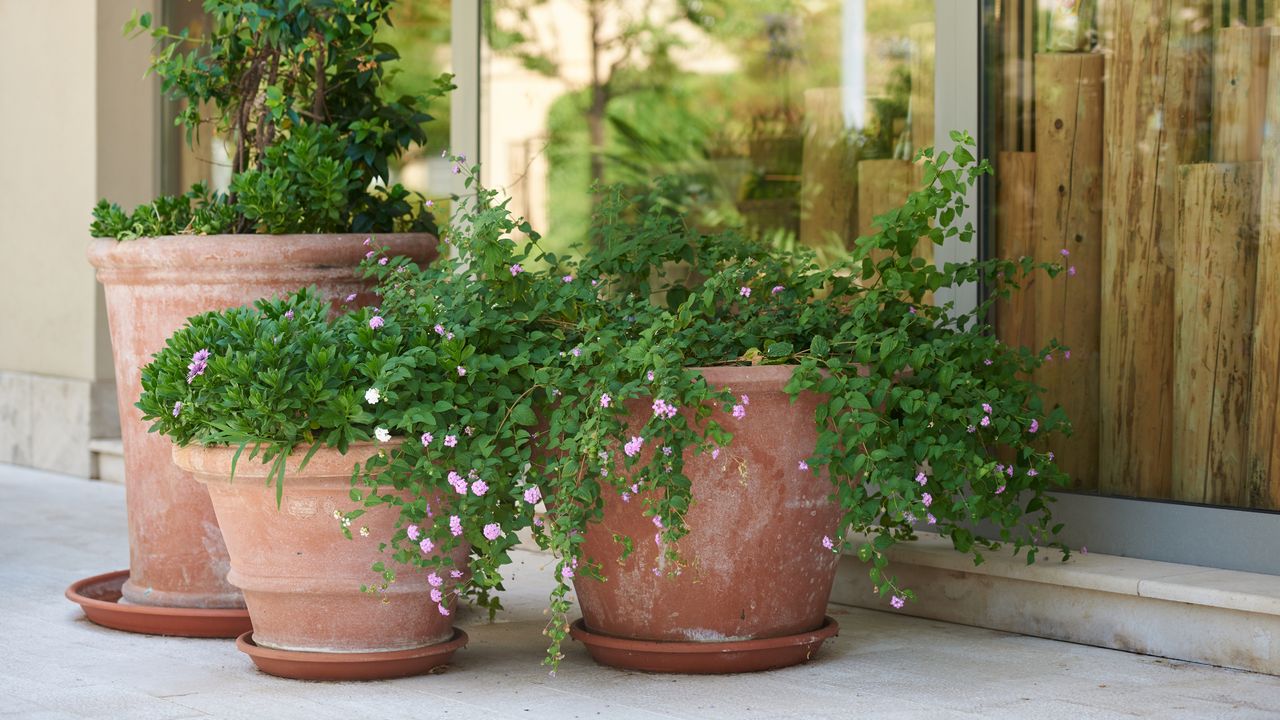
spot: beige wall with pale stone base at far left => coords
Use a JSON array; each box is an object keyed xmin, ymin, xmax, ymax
[{"xmin": 0, "ymin": 0, "xmax": 159, "ymax": 474}]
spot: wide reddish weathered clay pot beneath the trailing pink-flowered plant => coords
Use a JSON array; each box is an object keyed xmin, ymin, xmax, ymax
[{"xmin": 575, "ymin": 365, "xmax": 840, "ymax": 671}]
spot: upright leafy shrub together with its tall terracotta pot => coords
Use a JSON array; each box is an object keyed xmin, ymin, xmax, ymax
[{"xmin": 74, "ymin": 0, "xmax": 451, "ymax": 634}]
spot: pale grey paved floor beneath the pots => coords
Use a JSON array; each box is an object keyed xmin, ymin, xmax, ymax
[{"xmin": 0, "ymin": 465, "xmax": 1280, "ymax": 720}]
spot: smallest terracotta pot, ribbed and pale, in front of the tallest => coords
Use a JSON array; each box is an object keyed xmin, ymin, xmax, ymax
[{"xmin": 173, "ymin": 443, "xmax": 467, "ymax": 653}]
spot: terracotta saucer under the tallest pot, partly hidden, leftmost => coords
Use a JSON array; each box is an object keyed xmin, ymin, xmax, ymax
[{"xmin": 67, "ymin": 570, "xmax": 253, "ymax": 638}]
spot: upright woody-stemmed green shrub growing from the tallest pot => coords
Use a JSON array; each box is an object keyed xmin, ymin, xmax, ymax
[{"xmin": 91, "ymin": 0, "xmax": 453, "ymax": 240}]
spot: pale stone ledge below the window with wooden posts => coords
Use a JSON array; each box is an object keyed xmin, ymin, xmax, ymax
[{"xmin": 832, "ymin": 533, "xmax": 1280, "ymax": 675}]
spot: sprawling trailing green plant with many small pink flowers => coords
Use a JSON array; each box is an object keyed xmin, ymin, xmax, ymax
[{"xmin": 353, "ymin": 128, "xmax": 1069, "ymax": 665}]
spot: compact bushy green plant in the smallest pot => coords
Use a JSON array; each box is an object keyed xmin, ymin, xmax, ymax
[{"xmin": 137, "ymin": 283, "xmax": 435, "ymax": 500}]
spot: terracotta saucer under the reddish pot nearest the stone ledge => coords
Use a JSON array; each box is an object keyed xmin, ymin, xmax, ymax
[{"xmin": 570, "ymin": 616, "xmax": 840, "ymax": 674}]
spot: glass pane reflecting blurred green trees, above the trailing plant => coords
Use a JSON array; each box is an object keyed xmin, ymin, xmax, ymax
[{"xmin": 481, "ymin": 0, "xmax": 934, "ymax": 254}]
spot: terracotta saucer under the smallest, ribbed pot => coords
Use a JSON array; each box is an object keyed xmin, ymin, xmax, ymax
[{"xmin": 236, "ymin": 628, "xmax": 468, "ymax": 680}]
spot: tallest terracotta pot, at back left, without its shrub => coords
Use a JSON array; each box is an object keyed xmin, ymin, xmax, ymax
[{"xmin": 88, "ymin": 234, "xmax": 435, "ymax": 609}]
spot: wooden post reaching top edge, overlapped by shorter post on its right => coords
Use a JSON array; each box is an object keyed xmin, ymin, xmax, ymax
[{"xmin": 1098, "ymin": 0, "xmax": 1211, "ymax": 498}]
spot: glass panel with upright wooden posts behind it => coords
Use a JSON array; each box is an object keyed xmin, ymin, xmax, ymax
[{"xmin": 991, "ymin": 0, "xmax": 1280, "ymax": 510}]
